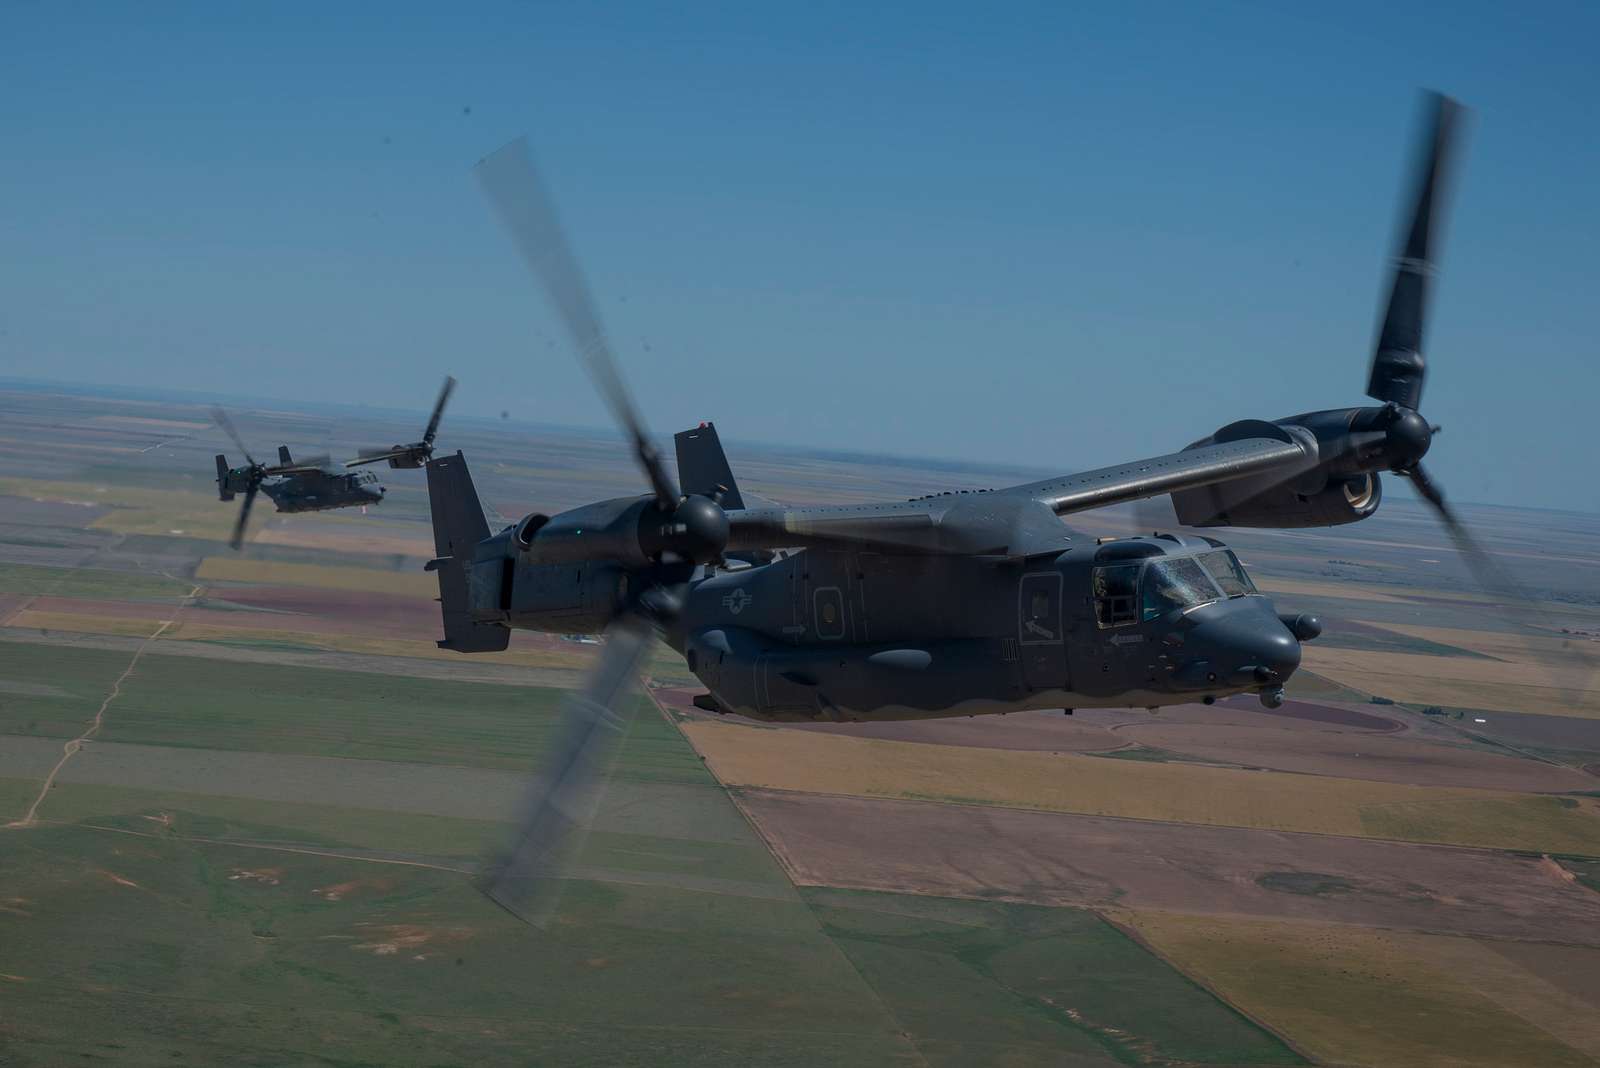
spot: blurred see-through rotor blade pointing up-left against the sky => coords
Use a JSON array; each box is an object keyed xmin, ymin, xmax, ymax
[{"xmin": 474, "ymin": 137, "xmax": 678, "ymax": 512}]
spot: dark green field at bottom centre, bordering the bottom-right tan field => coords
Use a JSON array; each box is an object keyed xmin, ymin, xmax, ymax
[{"xmin": 805, "ymin": 889, "xmax": 1306, "ymax": 1066}]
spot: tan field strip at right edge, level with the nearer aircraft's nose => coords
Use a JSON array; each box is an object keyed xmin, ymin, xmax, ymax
[{"xmin": 1304, "ymin": 644, "xmax": 1600, "ymax": 716}]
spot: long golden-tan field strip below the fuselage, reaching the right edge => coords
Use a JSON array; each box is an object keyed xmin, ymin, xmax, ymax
[{"xmin": 682, "ymin": 721, "xmax": 1600, "ymax": 855}]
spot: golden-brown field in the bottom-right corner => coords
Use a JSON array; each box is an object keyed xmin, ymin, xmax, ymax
[{"xmin": 1114, "ymin": 911, "xmax": 1600, "ymax": 1068}]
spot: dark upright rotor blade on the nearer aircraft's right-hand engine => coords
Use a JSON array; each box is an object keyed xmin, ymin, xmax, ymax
[{"xmin": 1366, "ymin": 93, "xmax": 1464, "ymax": 409}]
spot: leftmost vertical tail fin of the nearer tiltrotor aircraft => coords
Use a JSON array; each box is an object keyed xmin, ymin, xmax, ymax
[{"xmin": 427, "ymin": 452, "xmax": 510, "ymax": 652}]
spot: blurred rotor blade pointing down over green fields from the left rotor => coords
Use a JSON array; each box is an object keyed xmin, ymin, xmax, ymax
[{"xmin": 482, "ymin": 616, "xmax": 653, "ymax": 926}]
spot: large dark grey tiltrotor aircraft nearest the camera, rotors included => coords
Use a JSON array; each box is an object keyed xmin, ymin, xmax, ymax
[{"xmin": 427, "ymin": 96, "xmax": 1493, "ymax": 920}]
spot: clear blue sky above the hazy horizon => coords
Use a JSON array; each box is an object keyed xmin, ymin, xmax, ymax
[{"xmin": 0, "ymin": 0, "xmax": 1600, "ymax": 512}]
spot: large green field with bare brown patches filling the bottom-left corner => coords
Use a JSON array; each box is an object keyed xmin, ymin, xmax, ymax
[{"xmin": 0, "ymin": 827, "xmax": 914, "ymax": 1066}]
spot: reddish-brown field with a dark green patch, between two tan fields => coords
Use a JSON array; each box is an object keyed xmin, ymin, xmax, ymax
[{"xmin": 738, "ymin": 790, "xmax": 1600, "ymax": 946}]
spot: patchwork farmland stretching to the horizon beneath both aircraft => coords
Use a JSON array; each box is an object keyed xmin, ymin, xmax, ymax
[{"xmin": 0, "ymin": 390, "xmax": 1600, "ymax": 1068}]
